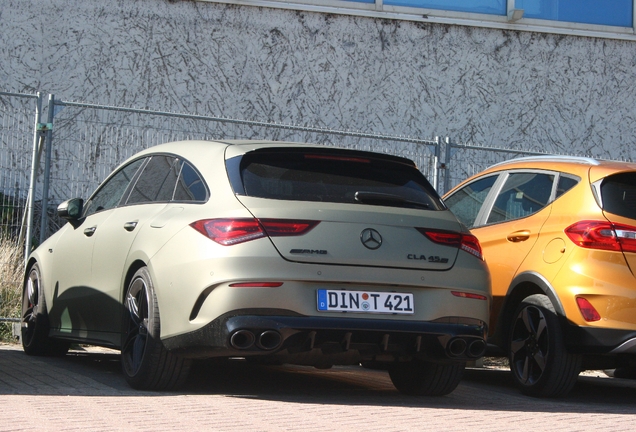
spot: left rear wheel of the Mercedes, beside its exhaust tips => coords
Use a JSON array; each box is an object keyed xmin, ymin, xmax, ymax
[{"xmin": 121, "ymin": 267, "xmax": 192, "ymax": 390}]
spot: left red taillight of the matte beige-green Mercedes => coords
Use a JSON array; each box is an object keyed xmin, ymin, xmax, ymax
[{"xmin": 190, "ymin": 218, "xmax": 318, "ymax": 246}]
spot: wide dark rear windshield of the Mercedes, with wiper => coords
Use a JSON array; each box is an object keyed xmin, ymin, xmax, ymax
[{"xmin": 228, "ymin": 149, "xmax": 445, "ymax": 210}]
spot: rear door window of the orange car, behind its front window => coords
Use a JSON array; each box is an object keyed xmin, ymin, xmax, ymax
[{"xmin": 487, "ymin": 173, "xmax": 554, "ymax": 223}]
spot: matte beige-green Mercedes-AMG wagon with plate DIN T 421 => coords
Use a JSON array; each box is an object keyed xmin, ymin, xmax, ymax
[{"xmin": 22, "ymin": 141, "xmax": 490, "ymax": 395}]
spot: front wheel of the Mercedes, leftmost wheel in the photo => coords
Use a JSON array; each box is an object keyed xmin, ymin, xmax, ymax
[{"xmin": 20, "ymin": 263, "xmax": 70, "ymax": 356}]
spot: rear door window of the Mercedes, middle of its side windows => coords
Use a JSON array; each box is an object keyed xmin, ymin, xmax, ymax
[{"xmin": 126, "ymin": 155, "xmax": 180, "ymax": 204}]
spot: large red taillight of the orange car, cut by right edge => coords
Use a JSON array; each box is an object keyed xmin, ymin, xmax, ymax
[{"xmin": 565, "ymin": 221, "xmax": 636, "ymax": 252}]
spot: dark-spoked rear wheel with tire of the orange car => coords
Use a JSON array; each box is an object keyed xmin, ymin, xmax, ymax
[{"xmin": 509, "ymin": 294, "xmax": 581, "ymax": 397}]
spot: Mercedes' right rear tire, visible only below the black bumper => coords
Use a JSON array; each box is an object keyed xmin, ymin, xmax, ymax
[{"xmin": 389, "ymin": 361, "xmax": 465, "ymax": 396}]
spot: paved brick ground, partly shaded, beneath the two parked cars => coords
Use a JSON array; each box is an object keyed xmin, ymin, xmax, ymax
[{"xmin": 0, "ymin": 344, "xmax": 636, "ymax": 432}]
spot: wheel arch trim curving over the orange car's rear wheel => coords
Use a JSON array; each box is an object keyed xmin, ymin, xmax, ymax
[{"xmin": 489, "ymin": 272, "xmax": 565, "ymax": 352}]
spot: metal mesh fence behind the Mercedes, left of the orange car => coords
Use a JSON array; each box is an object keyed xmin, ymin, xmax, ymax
[{"xmin": 0, "ymin": 92, "xmax": 441, "ymax": 255}]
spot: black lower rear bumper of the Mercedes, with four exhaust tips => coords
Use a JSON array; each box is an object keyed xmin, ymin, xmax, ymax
[{"xmin": 163, "ymin": 310, "xmax": 487, "ymax": 364}]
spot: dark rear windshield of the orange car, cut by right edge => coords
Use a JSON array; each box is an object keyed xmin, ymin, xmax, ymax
[{"xmin": 601, "ymin": 172, "xmax": 636, "ymax": 219}]
